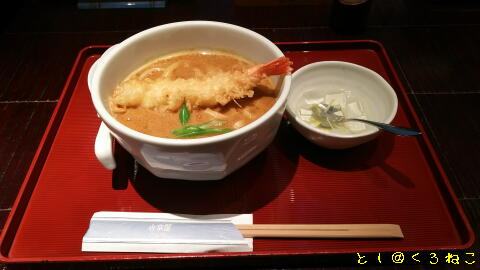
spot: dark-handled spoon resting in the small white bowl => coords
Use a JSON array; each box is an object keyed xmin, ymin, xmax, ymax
[{"xmin": 313, "ymin": 103, "xmax": 422, "ymax": 136}]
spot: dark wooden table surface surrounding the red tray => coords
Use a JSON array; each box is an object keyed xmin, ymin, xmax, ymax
[{"xmin": 0, "ymin": 0, "xmax": 480, "ymax": 269}]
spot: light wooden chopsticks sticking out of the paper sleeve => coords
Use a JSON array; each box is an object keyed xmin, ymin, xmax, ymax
[{"xmin": 236, "ymin": 224, "xmax": 403, "ymax": 239}]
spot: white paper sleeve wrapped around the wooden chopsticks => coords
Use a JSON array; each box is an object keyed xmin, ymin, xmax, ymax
[{"xmin": 82, "ymin": 211, "xmax": 253, "ymax": 253}]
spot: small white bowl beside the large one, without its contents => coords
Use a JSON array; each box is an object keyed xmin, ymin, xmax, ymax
[{"xmin": 287, "ymin": 61, "xmax": 398, "ymax": 149}]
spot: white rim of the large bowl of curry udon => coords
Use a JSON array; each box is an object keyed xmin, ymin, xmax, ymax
[{"xmin": 91, "ymin": 20, "xmax": 292, "ymax": 147}]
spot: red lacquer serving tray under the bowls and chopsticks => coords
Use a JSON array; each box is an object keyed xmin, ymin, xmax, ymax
[{"xmin": 1, "ymin": 41, "xmax": 474, "ymax": 262}]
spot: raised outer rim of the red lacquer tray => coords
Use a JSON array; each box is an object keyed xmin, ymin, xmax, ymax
[{"xmin": 0, "ymin": 39, "xmax": 475, "ymax": 263}]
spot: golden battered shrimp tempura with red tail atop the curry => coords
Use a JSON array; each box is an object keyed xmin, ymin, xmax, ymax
[{"xmin": 111, "ymin": 57, "xmax": 292, "ymax": 113}]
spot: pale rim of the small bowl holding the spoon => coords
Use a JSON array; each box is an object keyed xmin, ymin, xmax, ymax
[{"xmin": 286, "ymin": 61, "xmax": 398, "ymax": 139}]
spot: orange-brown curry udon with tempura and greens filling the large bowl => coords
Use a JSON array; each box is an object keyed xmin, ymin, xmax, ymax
[{"xmin": 109, "ymin": 50, "xmax": 291, "ymax": 138}]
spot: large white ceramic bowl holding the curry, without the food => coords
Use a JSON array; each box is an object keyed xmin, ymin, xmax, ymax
[{"xmin": 89, "ymin": 21, "xmax": 291, "ymax": 180}]
